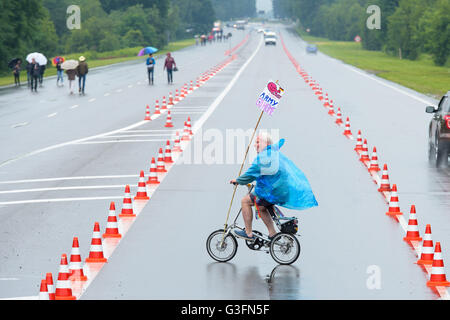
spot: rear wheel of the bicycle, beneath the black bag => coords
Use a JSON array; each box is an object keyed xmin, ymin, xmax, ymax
[{"xmin": 270, "ymin": 232, "xmax": 300, "ymax": 264}]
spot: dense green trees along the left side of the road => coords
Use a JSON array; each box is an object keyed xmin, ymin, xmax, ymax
[{"xmin": 0, "ymin": 0, "xmax": 256, "ymax": 72}]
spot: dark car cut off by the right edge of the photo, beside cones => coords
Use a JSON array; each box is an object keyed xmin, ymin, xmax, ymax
[{"xmin": 425, "ymin": 91, "xmax": 450, "ymax": 167}]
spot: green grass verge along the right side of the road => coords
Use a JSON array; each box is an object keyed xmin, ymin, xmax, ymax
[{"xmin": 300, "ymin": 34, "xmax": 450, "ymax": 99}]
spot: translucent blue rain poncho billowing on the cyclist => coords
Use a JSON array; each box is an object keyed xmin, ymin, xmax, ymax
[{"xmin": 236, "ymin": 139, "xmax": 318, "ymax": 210}]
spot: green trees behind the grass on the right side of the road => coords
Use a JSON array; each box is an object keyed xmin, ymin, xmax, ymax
[{"xmin": 273, "ymin": 0, "xmax": 450, "ymax": 66}]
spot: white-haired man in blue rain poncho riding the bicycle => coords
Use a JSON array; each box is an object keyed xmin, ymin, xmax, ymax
[{"xmin": 230, "ymin": 132, "xmax": 318, "ymax": 240}]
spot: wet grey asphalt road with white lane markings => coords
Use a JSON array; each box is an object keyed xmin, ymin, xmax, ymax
[{"xmin": 0, "ymin": 23, "xmax": 450, "ymax": 299}]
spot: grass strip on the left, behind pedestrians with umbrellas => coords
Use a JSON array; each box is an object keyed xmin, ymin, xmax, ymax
[{"xmin": 0, "ymin": 39, "xmax": 195, "ymax": 86}]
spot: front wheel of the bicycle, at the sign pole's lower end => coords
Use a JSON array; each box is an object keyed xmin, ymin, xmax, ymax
[{"xmin": 206, "ymin": 229, "xmax": 237, "ymax": 262}]
